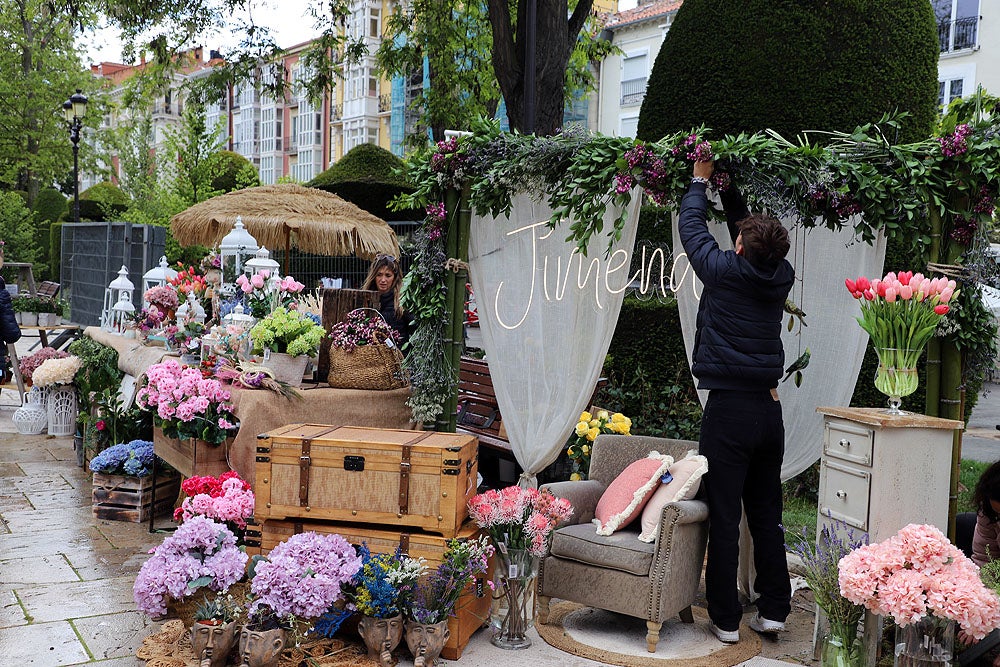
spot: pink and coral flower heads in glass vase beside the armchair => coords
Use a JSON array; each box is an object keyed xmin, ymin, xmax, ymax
[{"xmin": 469, "ymin": 486, "xmax": 573, "ymax": 556}]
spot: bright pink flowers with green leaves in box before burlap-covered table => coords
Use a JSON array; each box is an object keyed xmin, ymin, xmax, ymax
[{"xmin": 136, "ymin": 359, "xmax": 237, "ymax": 445}]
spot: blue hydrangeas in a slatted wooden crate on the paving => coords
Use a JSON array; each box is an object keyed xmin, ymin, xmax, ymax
[{"xmin": 90, "ymin": 440, "xmax": 181, "ymax": 523}]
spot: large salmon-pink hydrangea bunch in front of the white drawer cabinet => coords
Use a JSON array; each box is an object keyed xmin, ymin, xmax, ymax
[{"xmin": 838, "ymin": 523, "xmax": 1000, "ymax": 640}]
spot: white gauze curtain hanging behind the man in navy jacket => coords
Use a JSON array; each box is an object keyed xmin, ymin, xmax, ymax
[{"xmin": 673, "ymin": 205, "xmax": 885, "ymax": 480}]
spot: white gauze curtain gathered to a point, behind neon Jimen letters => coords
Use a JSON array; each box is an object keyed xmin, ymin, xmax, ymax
[{"xmin": 469, "ymin": 192, "xmax": 641, "ymax": 486}]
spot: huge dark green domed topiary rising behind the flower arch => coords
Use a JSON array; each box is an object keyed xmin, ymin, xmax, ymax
[{"xmin": 638, "ymin": 0, "xmax": 939, "ymax": 142}]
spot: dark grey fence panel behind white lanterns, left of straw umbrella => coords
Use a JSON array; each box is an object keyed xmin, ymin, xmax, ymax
[{"xmin": 60, "ymin": 222, "xmax": 167, "ymax": 326}]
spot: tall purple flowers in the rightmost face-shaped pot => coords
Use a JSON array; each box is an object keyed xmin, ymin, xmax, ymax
[{"xmin": 403, "ymin": 536, "xmax": 493, "ymax": 667}]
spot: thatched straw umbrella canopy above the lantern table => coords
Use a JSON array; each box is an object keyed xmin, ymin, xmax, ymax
[{"xmin": 170, "ymin": 184, "xmax": 399, "ymax": 262}]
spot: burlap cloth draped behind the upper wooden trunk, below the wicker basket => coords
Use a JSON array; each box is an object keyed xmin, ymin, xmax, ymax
[{"xmin": 229, "ymin": 385, "xmax": 414, "ymax": 484}]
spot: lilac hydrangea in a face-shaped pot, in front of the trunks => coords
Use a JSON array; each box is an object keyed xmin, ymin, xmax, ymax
[{"xmin": 244, "ymin": 523, "xmax": 361, "ymax": 665}]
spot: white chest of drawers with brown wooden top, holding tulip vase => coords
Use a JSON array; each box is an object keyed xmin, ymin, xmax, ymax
[{"xmin": 816, "ymin": 407, "xmax": 963, "ymax": 665}]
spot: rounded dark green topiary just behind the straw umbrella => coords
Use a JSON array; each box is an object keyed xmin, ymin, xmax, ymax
[{"xmin": 306, "ymin": 144, "xmax": 414, "ymax": 220}]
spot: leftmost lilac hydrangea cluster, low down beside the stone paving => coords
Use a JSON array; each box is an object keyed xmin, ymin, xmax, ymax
[{"xmin": 132, "ymin": 516, "xmax": 248, "ymax": 620}]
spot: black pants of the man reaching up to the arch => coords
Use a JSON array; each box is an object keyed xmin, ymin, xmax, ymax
[{"xmin": 699, "ymin": 389, "xmax": 791, "ymax": 631}]
